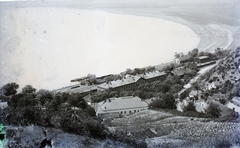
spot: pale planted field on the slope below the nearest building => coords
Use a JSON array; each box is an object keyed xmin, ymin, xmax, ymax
[{"xmin": 109, "ymin": 110, "xmax": 240, "ymax": 147}]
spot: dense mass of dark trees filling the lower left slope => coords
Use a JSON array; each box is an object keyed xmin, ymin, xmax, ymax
[{"xmin": 0, "ymin": 83, "xmax": 106, "ymax": 138}]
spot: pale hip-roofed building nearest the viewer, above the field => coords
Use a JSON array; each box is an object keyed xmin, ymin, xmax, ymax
[{"xmin": 97, "ymin": 96, "xmax": 148, "ymax": 117}]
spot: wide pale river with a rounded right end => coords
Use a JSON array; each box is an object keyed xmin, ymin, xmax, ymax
[{"xmin": 0, "ymin": 7, "xmax": 200, "ymax": 89}]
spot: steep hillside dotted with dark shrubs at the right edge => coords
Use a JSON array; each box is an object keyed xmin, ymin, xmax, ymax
[{"xmin": 199, "ymin": 47, "xmax": 240, "ymax": 112}]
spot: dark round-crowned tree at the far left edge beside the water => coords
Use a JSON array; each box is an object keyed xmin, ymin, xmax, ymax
[{"xmin": 1, "ymin": 82, "xmax": 19, "ymax": 96}]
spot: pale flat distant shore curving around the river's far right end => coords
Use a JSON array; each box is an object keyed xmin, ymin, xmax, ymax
[{"xmin": 101, "ymin": 6, "xmax": 240, "ymax": 52}]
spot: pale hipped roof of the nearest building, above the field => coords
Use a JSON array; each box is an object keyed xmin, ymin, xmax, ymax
[{"xmin": 97, "ymin": 96, "xmax": 148, "ymax": 114}]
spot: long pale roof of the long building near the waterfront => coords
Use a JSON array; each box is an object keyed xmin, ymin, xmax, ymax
[{"xmin": 98, "ymin": 71, "xmax": 166, "ymax": 89}]
